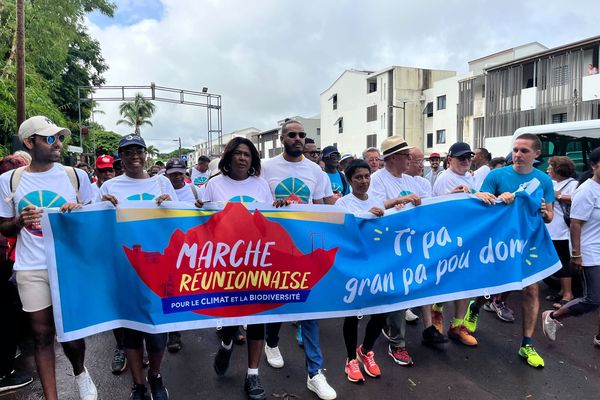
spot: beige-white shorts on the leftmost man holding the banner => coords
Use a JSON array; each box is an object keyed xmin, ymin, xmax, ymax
[{"xmin": 16, "ymin": 269, "xmax": 52, "ymax": 312}]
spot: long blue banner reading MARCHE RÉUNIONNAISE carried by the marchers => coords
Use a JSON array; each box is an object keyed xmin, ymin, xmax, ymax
[{"xmin": 43, "ymin": 184, "xmax": 560, "ymax": 341}]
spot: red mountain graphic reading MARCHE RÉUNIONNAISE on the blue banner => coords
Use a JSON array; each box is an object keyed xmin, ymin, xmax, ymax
[{"xmin": 123, "ymin": 203, "xmax": 338, "ymax": 317}]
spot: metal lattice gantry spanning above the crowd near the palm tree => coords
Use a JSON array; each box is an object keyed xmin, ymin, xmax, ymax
[{"xmin": 77, "ymin": 82, "xmax": 223, "ymax": 155}]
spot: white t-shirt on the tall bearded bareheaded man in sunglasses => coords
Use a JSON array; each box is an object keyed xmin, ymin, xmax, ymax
[{"xmin": 261, "ymin": 154, "xmax": 333, "ymax": 204}]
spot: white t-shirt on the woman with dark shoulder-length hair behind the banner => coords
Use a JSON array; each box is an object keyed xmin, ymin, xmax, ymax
[{"xmin": 202, "ymin": 175, "xmax": 273, "ymax": 204}]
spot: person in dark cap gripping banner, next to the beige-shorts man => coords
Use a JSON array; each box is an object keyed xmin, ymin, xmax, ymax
[{"xmin": 100, "ymin": 135, "xmax": 178, "ymax": 400}]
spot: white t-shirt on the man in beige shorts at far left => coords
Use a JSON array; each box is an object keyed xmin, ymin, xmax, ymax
[{"xmin": 0, "ymin": 163, "xmax": 95, "ymax": 271}]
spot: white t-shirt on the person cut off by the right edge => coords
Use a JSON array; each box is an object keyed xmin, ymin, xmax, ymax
[{"xmin": 571, "ymin": 179, "xmax": 600, "ymax": 267}]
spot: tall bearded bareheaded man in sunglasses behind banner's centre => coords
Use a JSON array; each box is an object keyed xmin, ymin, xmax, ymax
[{"xmin": 261, "ymin": 120, "xmax": 337, "ymax": 400}]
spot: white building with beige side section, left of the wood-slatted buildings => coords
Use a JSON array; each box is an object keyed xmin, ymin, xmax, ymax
[{"xmin": 320, "ymin": 66, "xmax": 456, "ymax": 155}]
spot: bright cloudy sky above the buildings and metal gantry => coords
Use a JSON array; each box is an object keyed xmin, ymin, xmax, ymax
[{"xmin": 89, "ymin": 0, "xmax": 600, "ymax": 151}]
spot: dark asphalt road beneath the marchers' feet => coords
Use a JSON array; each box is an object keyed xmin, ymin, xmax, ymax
[{"xmin": 0, "ymin": 293, "xmax": 600, "ymax": 400}]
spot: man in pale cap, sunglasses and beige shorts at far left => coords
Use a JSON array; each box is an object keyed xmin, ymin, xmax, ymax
[{"xmin": 0, "ymin": 116, "xmax": 98, "ymax": 400}]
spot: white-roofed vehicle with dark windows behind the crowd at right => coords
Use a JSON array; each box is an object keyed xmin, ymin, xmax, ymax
[{"xmin": 485, "ymin": 119, "xmax": 600, "ymax": 175}]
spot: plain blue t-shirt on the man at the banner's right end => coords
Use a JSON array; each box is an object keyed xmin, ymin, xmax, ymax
[{"xmin": 480, "ymin": 165, "xmax": 554, "ymax": 203}]
